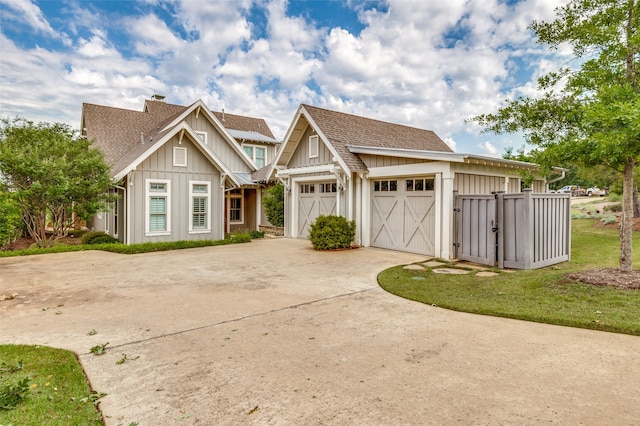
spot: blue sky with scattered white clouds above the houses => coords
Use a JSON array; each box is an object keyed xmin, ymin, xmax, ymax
[{"xmin": 0, "ymin": 0, "xmax": 566, "ymax": 156}]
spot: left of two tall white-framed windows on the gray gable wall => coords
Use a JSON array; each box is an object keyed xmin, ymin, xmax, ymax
[{"xmin": 145, "ymin": 179, "xmax": 171, "ymax": 235}]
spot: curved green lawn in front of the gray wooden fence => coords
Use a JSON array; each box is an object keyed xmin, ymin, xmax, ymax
[{"xmin": 378, "ymin": 220, "xmax": 640, "ymax": 335}]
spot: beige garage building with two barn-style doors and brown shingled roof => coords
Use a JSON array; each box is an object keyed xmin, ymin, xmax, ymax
[{"xmin": 270, "ymin": 105, "xmax": 565, "ymax": 262}]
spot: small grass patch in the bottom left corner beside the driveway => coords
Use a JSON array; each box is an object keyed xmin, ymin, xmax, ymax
[{"xmin": 0, "ymin": 345, "xmax": 104, "ymax": 426}]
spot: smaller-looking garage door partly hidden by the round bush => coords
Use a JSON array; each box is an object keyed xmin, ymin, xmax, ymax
[{"xmin": 298, "ymin": 182, "xmax": 337, "ymax": 238}]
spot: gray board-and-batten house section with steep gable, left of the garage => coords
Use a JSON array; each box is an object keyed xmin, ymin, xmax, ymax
[{"xmin": 81, "ymin": 96, "xmax": 279, "ymax": 244}]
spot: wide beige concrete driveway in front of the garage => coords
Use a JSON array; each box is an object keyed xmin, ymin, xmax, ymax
[{"xmin": 0, "ymin": 239, "xmax": 640, "ymax": 425}]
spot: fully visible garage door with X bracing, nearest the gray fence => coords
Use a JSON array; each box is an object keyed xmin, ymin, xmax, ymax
[{"xmin": 371, "ymin": 178, "xmax": 435, "ymax": 256}]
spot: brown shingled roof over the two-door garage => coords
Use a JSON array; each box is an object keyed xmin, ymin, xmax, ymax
[{"xmin": 300, "ymin": 104, "xmax": 453, "ymax": 171}]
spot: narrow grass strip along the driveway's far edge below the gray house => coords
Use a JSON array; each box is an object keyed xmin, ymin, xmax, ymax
[{"xmin": 0, "ymin": 233, "xmax": 251, "ymax": 258}]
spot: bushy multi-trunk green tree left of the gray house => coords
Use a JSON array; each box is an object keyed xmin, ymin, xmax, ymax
[{"xmin": 0, "ymin": 118, "xmax": 112, "ymax": 247}]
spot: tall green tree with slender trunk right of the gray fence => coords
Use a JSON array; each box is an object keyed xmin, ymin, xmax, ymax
[{"xmin": 473, "ymin": 0, "xmax": 640, "ymax": 271}]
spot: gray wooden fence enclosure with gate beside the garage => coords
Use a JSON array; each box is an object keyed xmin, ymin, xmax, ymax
[{"xmin": 454, "ymin": 190, "xmax": 571, "ymax": 269}]
